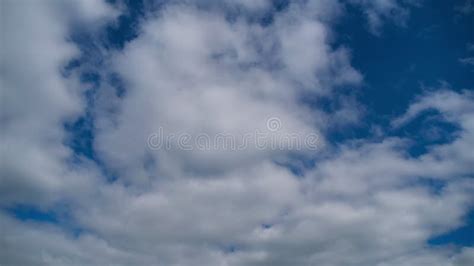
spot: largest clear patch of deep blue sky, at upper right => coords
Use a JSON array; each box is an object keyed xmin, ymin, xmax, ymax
[{"xmin": 336, "ymin": 0, "xmax": 474, "ymax": 116}]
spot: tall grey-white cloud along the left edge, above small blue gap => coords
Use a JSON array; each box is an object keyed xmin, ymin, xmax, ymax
[{"xmin": 0, "ymin": 1, "xmax": 114, "ymax": 204}]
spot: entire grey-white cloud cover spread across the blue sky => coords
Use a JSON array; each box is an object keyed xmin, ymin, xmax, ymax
[{"xmin": 0, "ymin": 1, "xmax": 474, "ymax": 266}]
